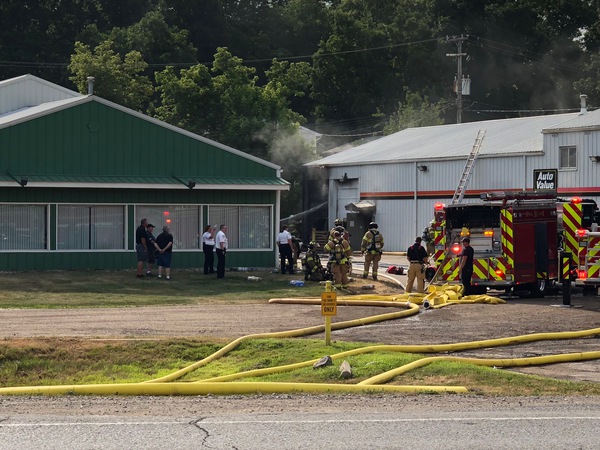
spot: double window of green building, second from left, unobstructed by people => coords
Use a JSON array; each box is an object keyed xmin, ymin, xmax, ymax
[{"xmin": 57, "ymin": 205, "xmax": 125, "ymax": 250}]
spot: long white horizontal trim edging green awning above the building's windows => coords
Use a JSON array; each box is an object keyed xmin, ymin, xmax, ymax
[{"xmin": 0, "ymin": 181, "xmax": 290, "ymax": 191}]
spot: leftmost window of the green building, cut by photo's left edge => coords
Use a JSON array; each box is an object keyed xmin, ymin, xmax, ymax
[{"xmin": 0, "ymin": 205, "xmax": 48, "ymax": 250}]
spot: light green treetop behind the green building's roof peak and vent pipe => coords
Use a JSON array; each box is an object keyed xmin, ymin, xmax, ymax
[{"xmin": 69, "ymin": 41, "xmax": 153, "ymax": 111}]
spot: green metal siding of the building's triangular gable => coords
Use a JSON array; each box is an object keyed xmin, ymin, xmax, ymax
[{"xmin": 0, "ymin": 102, "xmax": 276, "ymax": 178}]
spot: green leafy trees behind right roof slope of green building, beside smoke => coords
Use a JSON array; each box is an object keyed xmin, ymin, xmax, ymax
[{"xmin": 155, "ymin": 48, "xmax": 314, "ymax": 217}]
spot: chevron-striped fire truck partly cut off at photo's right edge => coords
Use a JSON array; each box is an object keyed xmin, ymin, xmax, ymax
[{"xmin": 558, "ymin": 197, "xmax": 600, "ymax": 289}]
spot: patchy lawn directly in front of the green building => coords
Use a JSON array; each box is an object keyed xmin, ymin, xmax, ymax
[{"xmin": 0, "ymin": 270, "xmax": 323, "ymax": 308}]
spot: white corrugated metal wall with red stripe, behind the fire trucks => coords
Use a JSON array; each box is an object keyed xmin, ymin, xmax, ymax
[{"xmin": 329, "ymin": 131, "xmax": 600, "ymax": 251}]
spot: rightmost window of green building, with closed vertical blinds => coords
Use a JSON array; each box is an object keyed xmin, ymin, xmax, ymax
[{"xmin": 208, "ymin": 206, "xmax": 271, "ymax": 249}]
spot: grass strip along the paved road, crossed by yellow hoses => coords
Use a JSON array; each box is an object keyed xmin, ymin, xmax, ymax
[{"xmin": 0, "ymin": 338, "xmax": 600, "ymax": 396}]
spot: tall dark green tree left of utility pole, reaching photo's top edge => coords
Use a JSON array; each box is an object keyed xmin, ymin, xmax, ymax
[{"xmin": 312, "ymin": 0, "xmax": 439, "ymax": 130}]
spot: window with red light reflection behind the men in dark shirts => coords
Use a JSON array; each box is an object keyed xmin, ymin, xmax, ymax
[{"xmin": 135, "ymin": 205, "xmax": 201, "ymax": 250}]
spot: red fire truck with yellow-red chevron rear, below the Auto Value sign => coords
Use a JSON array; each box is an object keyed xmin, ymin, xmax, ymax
[{"xmin": 432, "ymin": 191, "xmax": 560, "ymax": 297}]
